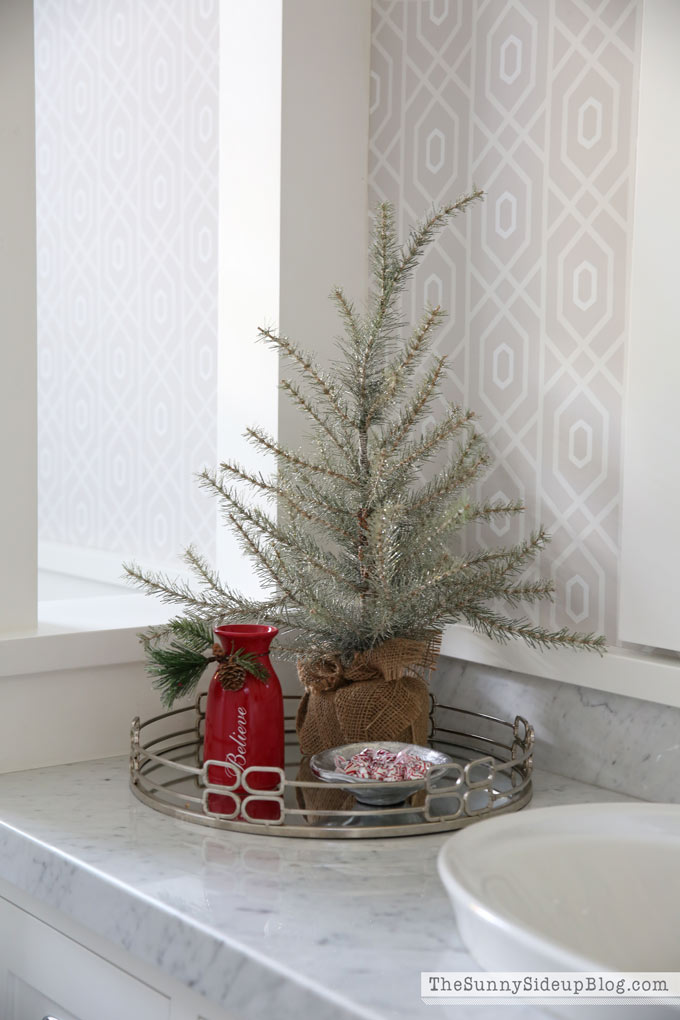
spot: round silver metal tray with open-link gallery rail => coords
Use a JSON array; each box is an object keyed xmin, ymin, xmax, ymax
[{"xmin": 129, "ymin": 694, "xmax": 533, "ymax": 839}]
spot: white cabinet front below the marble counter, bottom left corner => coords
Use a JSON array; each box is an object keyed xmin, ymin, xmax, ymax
[{"xmin": 0, "ymin": 883, "xmax": 238, "ymax": 1020}]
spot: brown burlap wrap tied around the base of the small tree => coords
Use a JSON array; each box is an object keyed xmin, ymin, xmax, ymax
[{"xmin": 297, "ymin": 632, "xmax": 441, "ymax": 755}]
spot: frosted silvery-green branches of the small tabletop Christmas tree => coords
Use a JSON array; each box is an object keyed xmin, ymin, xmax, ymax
[{"xmin": 125, "ymin": 191, "xmax": 605, "ymax": 718}]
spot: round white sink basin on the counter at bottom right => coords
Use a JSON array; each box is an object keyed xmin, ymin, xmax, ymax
[{"xmin": 438, "ymin": 804, "xmax": 680, "ymax": 971}]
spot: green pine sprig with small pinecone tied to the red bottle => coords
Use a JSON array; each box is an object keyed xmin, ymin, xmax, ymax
[{"xmin": 140, "ymin": 617, "xmax": 269, "ymax": 708}]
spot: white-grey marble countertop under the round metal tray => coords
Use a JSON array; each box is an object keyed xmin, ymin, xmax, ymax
[{"xmin": 0, "ymin": 759, "xmax": 625, "ymax": 1020}]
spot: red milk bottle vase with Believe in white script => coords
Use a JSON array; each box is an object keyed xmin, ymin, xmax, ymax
[{"xmin": 203, "ymin": 623, "xmax": 283, "ymax": 820}]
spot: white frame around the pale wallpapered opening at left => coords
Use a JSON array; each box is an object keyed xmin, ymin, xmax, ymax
[{"xmin": 0, "ymin": 0, "xmax": 370, "ymax": 676}]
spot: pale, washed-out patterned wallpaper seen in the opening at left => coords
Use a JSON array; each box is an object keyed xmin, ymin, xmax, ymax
[{"xmin": 35, "ymin": 0, "xmax": 218, "ymax": 563}]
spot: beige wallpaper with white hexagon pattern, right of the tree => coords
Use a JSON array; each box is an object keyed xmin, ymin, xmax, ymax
[{"xmin": 370, "ymin": 0, "xmax": 641, "ymax": 640}]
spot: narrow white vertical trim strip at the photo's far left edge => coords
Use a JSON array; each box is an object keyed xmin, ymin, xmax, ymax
[{"xmin": 0, "ymin": 0, "xmax": 37, "ymax": 633}]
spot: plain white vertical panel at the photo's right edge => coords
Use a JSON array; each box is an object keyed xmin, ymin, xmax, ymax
[{"xmin": 621, "ymin": 0, "xmax": 680, "ymax": 650}]
